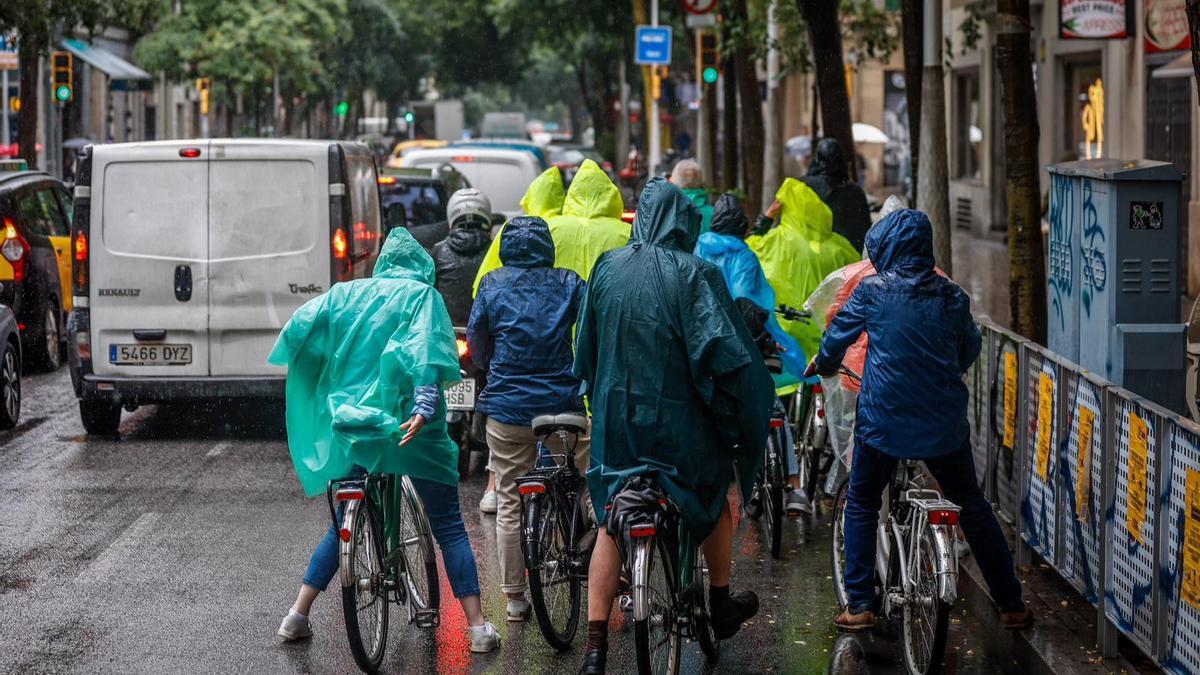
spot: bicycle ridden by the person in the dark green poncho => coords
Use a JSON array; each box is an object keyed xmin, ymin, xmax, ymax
[{"xmin": 610, "ymin": 476, "xmax": 720, "ymax": 675}]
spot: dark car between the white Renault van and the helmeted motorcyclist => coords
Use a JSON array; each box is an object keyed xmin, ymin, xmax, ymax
[{"xmin": 379, "ymin": 165, "xmax": 470, "ymax": 251}]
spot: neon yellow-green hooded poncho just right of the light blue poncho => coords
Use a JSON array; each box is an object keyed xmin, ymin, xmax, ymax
[{"xmin": 746, "ymin": 178, "xmax": 859, "ymax": 354}]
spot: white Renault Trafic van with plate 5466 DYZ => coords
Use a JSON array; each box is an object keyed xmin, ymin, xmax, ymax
[{"xmin": 68, "ymin": 139, "xmax": 383, "ymax": 434}]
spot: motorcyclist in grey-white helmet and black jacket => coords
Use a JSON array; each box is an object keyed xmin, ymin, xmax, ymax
[{"xmin": 433, "ymin": 187, "xmax": 492, "ymax": 327}]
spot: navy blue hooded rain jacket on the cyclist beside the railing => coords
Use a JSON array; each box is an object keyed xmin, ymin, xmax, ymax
[{"xmin": 817, "ymin": 209, "xmax": 980, "ymax": 459}]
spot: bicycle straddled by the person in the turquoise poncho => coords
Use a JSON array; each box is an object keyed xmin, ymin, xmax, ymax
[{"xmin": 325, "ymin": 473, "xmax": 440, "ymax": 673}]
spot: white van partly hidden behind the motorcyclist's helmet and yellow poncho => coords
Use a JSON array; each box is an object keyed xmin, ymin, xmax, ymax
[{"xmin": 404, "ymin": 145, "xmax": 541, "ymax": 218}]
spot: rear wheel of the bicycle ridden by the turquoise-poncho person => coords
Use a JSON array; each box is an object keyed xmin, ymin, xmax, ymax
[{"xmin": 340, "ymin": 500, "xmax": 388, "ymax": 673}]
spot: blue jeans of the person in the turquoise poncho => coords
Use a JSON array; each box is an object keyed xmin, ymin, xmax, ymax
[{"xmin": 304, "ymin": 477, "xmax": 479, "ymax": 598}]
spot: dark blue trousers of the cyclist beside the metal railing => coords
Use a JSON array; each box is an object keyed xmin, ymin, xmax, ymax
[{"xmin": 845, "ymin": 441, "xmax": 1025, "ymax": 614}]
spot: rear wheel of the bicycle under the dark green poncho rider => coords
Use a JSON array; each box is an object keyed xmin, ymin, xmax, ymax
[{"xmin": 632, "ymin": 537, "xmax": 680, "ymax": 675}]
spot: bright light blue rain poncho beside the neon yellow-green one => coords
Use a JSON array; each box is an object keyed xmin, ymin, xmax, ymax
[{"xmin": 696, "ymin": 232, "xmax": 809, "ymax": 386}]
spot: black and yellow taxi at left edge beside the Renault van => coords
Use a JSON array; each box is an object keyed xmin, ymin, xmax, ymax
[{"xmin": 0, "ymin": 171, "xmax": 71, "ymax": 370}]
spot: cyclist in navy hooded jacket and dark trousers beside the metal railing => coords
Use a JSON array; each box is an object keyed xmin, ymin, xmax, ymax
[{"xmin": 809, "ymin": 209, "xmax": 1032, "ymax": 631}]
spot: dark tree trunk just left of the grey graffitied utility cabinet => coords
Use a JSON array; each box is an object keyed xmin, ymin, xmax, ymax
[{"xmin": 996, "ymin": 0, "xmax": 1046, "ymax": 345}]
